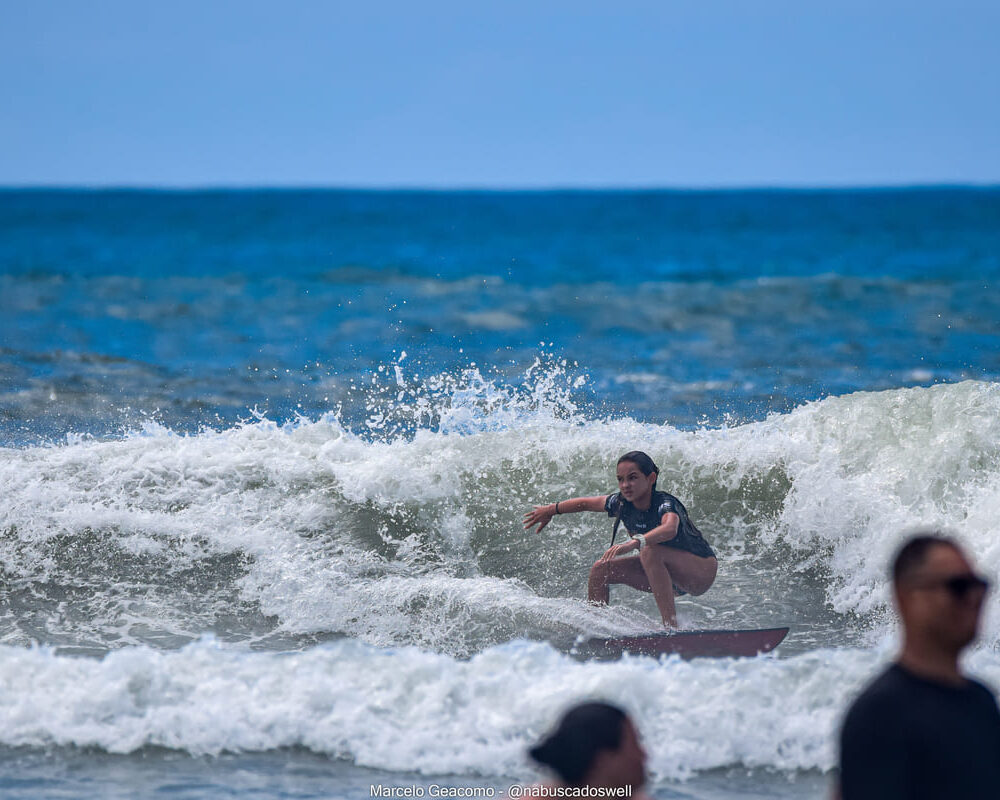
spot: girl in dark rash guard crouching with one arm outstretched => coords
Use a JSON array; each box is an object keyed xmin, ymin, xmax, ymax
[{"xmin": 524, "ymin": 450, "xmax": 719, "ymax": 628}]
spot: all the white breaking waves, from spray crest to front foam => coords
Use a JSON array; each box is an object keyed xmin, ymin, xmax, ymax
[{"xmin": 0, "ymin": 379, "xmax": 1000, "ymax": 780}]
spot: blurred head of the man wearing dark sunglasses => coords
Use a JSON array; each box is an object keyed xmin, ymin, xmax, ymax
[{"xmin": 892, "ymin": 533, "xmax": 988, "ymax": 655}]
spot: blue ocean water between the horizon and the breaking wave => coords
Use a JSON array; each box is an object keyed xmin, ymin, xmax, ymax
[{"xmin": 0, "ymin": 189, "xmax": 1000, "ymax": 443}]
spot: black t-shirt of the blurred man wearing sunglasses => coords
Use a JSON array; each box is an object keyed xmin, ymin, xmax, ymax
[{"xmin": 840, "ymin": 664, "xmax": 1000, "ymax": 800}]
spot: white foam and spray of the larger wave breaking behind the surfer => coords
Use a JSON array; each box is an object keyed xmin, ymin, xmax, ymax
[{"xmin": 0, "ymin": 380, "xmax": 1000, "ymax": 653}]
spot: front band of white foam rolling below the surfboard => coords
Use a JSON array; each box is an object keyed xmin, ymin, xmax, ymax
[{"xmin": 0, "ymin": 640, "xmax": 1000, "ymax": 778}]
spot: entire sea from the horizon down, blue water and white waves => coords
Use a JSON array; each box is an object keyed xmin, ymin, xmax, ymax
[{"xmin": 0, "ymin": 189, "xmax": 1000, "ymax": 800}]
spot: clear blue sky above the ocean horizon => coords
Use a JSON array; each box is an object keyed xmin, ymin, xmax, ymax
[{"xmin": 0, "ymin": 0, "xmax": 1000, "ymax": 187}]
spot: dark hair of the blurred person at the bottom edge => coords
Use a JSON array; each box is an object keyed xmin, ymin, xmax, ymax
[{"xmin": 528, "ymin": 703, "xmax": 627, "ymax": 785}]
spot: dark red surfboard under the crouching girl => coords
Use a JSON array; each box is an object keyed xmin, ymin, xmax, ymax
[{"xmin": 576, "ymin": 628, "xmax": 788, "ymax": 659}]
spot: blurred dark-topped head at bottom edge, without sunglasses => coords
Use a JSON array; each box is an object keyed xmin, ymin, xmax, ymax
[{"xmin": 528, "ymin": 702, "xmax": 646, "ymax": 790}]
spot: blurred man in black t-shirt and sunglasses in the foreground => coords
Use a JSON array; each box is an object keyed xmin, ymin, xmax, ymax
[{"xmin": 840, "ymin": 535, "xmax": 1000, "ymax": 800}]
